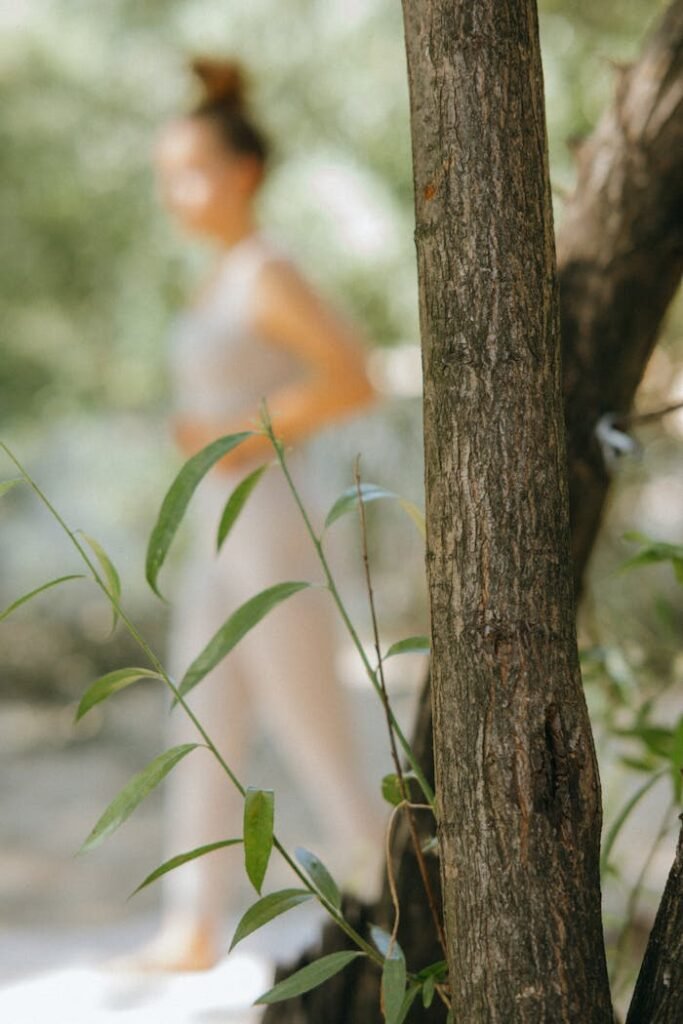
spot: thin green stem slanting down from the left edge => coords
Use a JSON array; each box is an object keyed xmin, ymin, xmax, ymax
[{"xmin": 0, "ymin": 441, "xmax": 383, "ymax": 966}]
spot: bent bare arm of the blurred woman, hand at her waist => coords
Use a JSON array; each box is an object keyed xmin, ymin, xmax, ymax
[{"xmin": 175, "ymin": 260, "xmax": 374, "ymax": 469}]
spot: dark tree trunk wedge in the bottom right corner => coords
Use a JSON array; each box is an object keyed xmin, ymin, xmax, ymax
[{"xmin": 627, "ymin": 819, "xmax": 683, "ymax": 1024}]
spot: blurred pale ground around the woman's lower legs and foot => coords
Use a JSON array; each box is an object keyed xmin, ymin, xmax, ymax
[{"xmin": 0, "ymin": 656, "xmax": 423, "ymax": 1024}]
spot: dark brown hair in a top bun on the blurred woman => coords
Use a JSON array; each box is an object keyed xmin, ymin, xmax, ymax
[{"xmin": 190, "ymin": 57, "xmax": 269, "ymax": 164}]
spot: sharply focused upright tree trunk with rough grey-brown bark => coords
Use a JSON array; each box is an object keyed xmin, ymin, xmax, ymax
[{"xmin": 403, "ymin": 0, "xmax": 612, "ymax": 1024}]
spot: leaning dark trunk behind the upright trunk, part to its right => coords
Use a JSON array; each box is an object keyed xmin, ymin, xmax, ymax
[{"xmin": 557, "ymin": 0, "xmax": 683, "ymax": 586}]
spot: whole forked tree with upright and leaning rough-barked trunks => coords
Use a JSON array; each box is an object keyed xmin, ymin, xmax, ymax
[{"xmin": 265, "ymin": 0, "xmax": 683, "ymax": 1024}]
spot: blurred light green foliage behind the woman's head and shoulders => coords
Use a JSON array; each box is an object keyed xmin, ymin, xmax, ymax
[{"xmin": 0, "ymin": 0, "xmax": 671, "ymax": 425}]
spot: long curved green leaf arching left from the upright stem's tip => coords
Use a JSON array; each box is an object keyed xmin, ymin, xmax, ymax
[{"xmin": 145, "ymin": 430, "xmax": 254, "ymax": 597}]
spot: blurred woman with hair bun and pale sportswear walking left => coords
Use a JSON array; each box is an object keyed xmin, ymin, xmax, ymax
[{"xmin": 142, "ymin": 60, "xmax": 379, "ymax": 970}]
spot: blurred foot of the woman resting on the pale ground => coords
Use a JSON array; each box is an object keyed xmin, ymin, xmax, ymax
[{"xmin": 106, "ymin": 922, "xmax": 218, "ymax": 973}]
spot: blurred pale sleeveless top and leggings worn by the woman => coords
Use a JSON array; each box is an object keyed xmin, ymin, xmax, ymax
[{"xmin": 165, "ymin": 234, "xmax": 377, "ymax": 919}]
